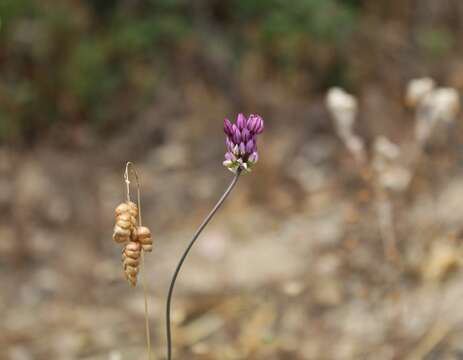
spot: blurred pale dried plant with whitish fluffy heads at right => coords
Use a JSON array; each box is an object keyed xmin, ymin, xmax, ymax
[{"xmin": 326, "ymin": 77, "xmax": 460, "ymax": 260}]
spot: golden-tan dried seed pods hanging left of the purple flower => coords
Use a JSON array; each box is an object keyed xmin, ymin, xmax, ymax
[{"xmin": 113, "ymin": 201, "xmax": 153, "ymax": 286}]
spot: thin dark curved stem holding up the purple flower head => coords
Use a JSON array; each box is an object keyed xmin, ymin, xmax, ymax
[{"xmin": 166, "ymin": 170, "xmax": 241, "ymax": 360}]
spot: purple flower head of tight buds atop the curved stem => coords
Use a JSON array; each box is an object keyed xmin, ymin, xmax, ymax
[{"xmin": 223, "ymin": 114, "xmax": 264, "ymax": 173}]
